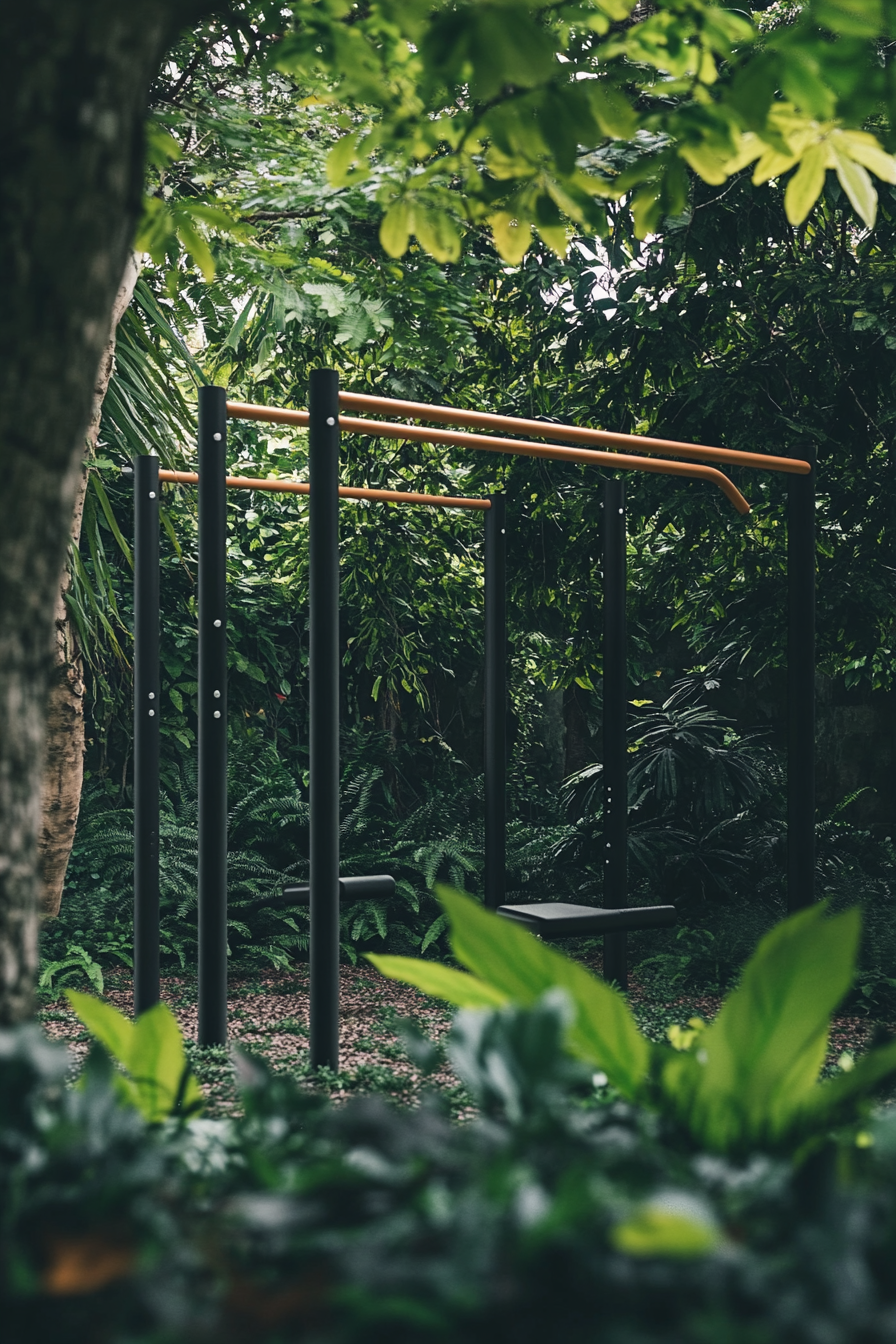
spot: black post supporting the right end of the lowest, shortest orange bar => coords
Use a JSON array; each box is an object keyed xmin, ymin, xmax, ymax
[{"xmin": 484, "ymin": 495, "xmax": 506, "ymax": 910}]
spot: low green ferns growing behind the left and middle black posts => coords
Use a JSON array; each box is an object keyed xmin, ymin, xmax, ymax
[{"xmin": 40, "ymin": 728, "xmax": 583, "ymax": 993}]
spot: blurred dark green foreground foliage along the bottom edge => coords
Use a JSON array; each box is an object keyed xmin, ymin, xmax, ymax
[{"xmin": 7, "ymin": 991, "xmax": 896, "ymax": 1344}]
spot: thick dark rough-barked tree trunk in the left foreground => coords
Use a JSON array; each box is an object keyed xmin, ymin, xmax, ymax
[{"xmin": 0, "ymin": 0, "xmax": 214, "ymax": 1024}]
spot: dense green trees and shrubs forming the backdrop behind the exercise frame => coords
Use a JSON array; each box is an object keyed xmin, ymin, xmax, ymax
[{"xmin": 61, "ymin": 5, "xmax": 896, "ymax": 1011}]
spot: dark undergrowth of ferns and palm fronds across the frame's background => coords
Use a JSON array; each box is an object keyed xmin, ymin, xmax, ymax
[{"xmin": 42, "ymin": 655, "xmax": 896, "ymax": 1016}]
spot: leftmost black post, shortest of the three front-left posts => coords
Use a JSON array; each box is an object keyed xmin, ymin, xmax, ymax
[{"xmin": 134, "ymin": 454, "xmax": 161, "ymax": 1016}]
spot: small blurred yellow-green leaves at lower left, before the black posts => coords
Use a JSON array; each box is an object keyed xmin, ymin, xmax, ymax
[{"xmin": 66, "ymin": 989, "xmax": 203, "ymax": 1124}]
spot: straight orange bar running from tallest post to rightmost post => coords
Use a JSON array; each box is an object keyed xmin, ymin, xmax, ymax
[{"xmin": 339, "ymin": 392, "xmax": 811, "ymax": 476}]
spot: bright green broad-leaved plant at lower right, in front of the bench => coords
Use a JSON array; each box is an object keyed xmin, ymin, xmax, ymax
[{"xmin": 369, "ymin": 891, "xmax": 896, "ymax": 1152}]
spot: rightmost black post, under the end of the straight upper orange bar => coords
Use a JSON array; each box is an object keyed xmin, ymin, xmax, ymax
[{"xmin": 787, "ymin": 454, "xmax": 815, "ymax": 911}]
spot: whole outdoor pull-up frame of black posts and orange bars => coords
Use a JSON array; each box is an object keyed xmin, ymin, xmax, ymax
[{"xmin": 134, "ymin": 370, "xmax": 814, "ymax": 1067}]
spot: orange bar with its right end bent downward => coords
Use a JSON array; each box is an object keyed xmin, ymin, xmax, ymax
[{"xmin": 227, "ymin": 402, "xmax": 750, "ymax": 513}]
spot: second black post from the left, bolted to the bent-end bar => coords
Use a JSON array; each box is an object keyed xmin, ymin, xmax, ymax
[{"xmin": 199, "ymin": 387, "xmax": 227, "ymax": 1046}]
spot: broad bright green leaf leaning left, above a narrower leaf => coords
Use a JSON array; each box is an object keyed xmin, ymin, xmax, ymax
[{"xmin": 437, "ymin": 887, "xmax": 650, "ymax": 1097}]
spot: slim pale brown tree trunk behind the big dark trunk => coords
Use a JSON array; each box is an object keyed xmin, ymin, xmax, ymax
[{"xmin": 38, "ymin": 253, "xmax": 140, "ymax": 917}]
